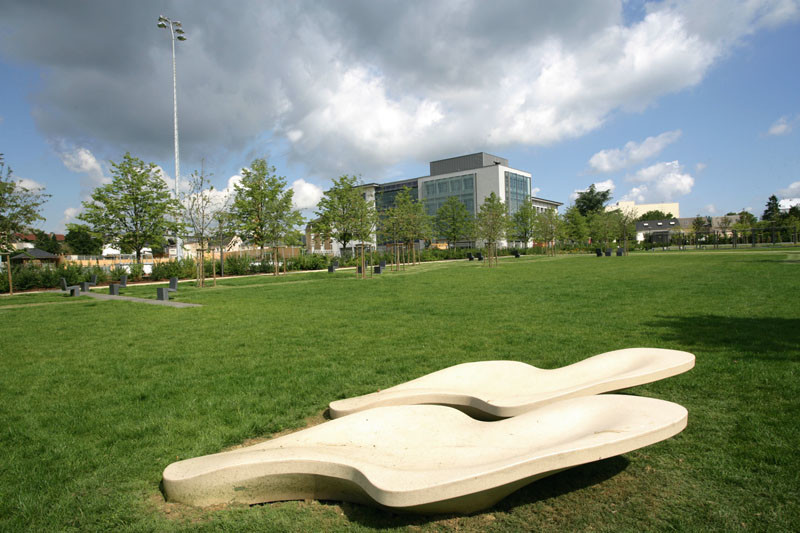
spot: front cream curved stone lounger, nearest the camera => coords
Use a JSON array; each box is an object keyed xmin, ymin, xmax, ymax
[{"xmin": 163, "ymin": 395, "xmax": 687, "ymax": 513}]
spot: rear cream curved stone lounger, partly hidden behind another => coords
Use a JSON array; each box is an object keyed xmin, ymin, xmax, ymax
[{"xmin": 329, "ymin": 348, "xmax": 694, "ymax": 420}]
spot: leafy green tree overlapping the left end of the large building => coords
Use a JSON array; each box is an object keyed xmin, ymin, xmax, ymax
[{"xmin": 315, "ymin": 174, "xmax": 365, "ymax": 258}]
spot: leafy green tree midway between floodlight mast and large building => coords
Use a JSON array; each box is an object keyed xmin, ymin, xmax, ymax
[{"xmin": 232, "ymin": 158, "xmax": 303, "ymax": 276}]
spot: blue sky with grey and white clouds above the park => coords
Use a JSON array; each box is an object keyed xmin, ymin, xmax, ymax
[{"xmin": 0, "ymin": 0, "xmax": 800, "ymax": 232}]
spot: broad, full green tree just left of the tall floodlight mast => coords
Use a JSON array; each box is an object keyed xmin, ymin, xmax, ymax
[{"xmin": 78, "ymin": 153, "xmax": 183, "ymax": 262}]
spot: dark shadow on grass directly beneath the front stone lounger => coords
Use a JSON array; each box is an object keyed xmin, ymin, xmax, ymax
[{"xmin": 325, "ymin": 456, "xmax": 630, "ymax": 528}]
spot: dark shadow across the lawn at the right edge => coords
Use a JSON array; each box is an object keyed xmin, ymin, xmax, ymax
[{"xmin": 645, "ymin": 315, "xmax": 800, "ymax": 361}]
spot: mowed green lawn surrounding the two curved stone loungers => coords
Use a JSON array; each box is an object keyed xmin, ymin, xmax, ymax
[{"xmin": 0, "ymin": 251, "xmax": 800, "ymax": 531}]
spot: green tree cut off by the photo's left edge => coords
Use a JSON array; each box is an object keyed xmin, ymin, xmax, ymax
[{"xmin": 0, "ymin": 154, "xmax": 50, "ymax": 294}]
